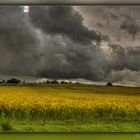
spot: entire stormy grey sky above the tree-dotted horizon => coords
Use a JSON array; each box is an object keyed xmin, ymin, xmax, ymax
[{"xmin": 0, "ymin": 5, "xmax": 140, "ymax": 83}]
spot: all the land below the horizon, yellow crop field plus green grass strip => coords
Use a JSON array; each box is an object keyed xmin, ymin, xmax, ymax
[{"xmin": 0, "ymin": 84, "xmax": 140, "ymax": 132}]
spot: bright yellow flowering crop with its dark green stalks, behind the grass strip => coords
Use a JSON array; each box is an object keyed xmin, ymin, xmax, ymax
[{"xmin": 0, "ymin": 86, "xmax": 140, "ymax": 120}]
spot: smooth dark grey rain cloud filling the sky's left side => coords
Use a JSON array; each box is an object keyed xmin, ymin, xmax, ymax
[{"xmin": 0, "ymin": 6, "xmax": 38, "ymax": 75}]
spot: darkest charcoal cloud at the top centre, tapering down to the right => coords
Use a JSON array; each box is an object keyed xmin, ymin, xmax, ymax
[{"xmin": 29, "ymin": 6, "xmax": 99, "ymax": 44}]
